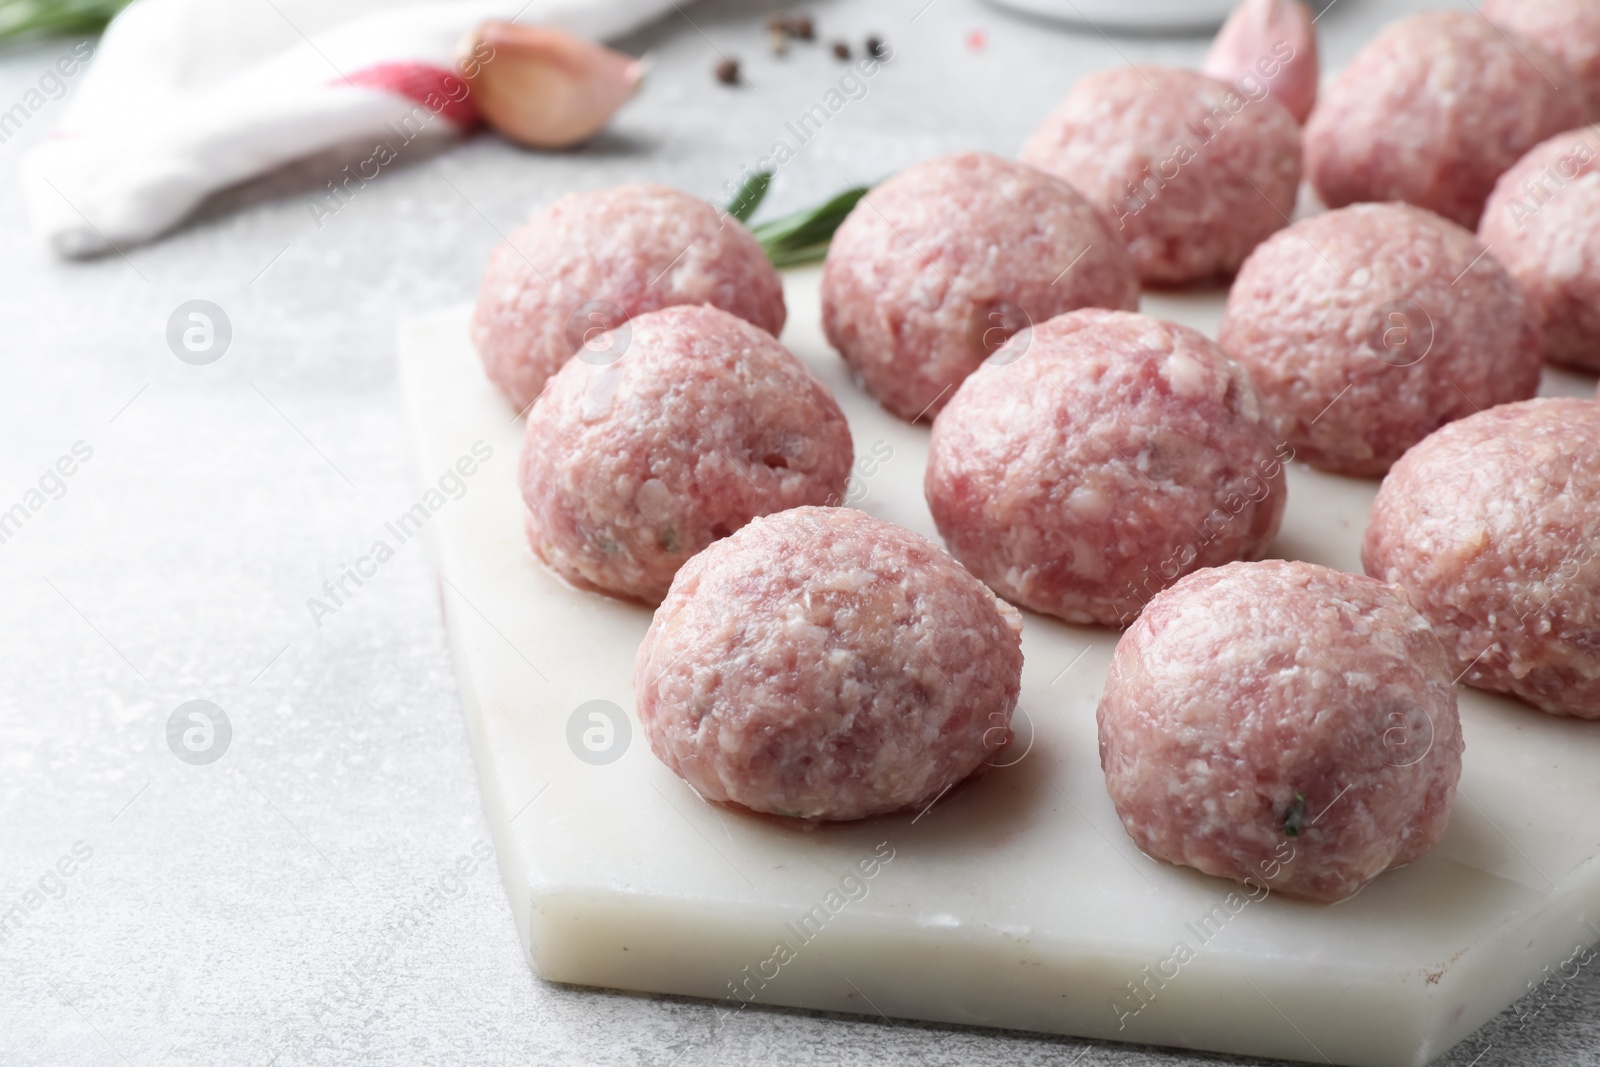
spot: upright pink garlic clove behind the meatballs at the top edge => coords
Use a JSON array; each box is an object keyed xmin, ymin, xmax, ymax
[{"xmin": 1200, "ymin": 0, "xmax": 1320, "ymax": 125}]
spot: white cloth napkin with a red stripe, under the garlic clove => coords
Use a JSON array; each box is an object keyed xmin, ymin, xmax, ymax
[{"xmin": 21, "ymin": 0, "xmax": 675, "ymax": 256}]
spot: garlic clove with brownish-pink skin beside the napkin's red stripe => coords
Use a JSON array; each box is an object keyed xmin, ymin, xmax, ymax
[{"xmin": 458, "ymin": 19, "xmax": 645, "ymax": 149}]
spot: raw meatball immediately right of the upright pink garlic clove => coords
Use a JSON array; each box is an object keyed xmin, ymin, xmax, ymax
[{"xmin": 1306, "ymin": 11, "xmax": 1587, "ymax": 227}]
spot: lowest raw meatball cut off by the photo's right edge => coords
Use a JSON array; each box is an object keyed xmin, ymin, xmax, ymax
[{"xmin": 1362, "ymin": 398, "xmax": 1600, "ymax": 718}]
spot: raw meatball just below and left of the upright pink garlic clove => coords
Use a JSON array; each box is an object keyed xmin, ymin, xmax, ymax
[{"xmin": 1022, "ymin": 67, "xmax": 1301, "ymax": 285}]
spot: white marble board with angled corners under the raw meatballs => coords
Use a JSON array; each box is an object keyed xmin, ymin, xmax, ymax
[{"xmin": 400, "ymin": 269, "xmax": 1600, "ymax": 1067}]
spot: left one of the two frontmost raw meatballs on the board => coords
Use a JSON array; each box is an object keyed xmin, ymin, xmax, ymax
[{"xmin": 634, "ymin": 507, "xmax": 1022, "ymax": 819}]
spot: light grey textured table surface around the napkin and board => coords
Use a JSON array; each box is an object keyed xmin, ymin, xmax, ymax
[{"xmin": 0, "ymin": 0, "xmax": 1600, "ymax": 1067}]
